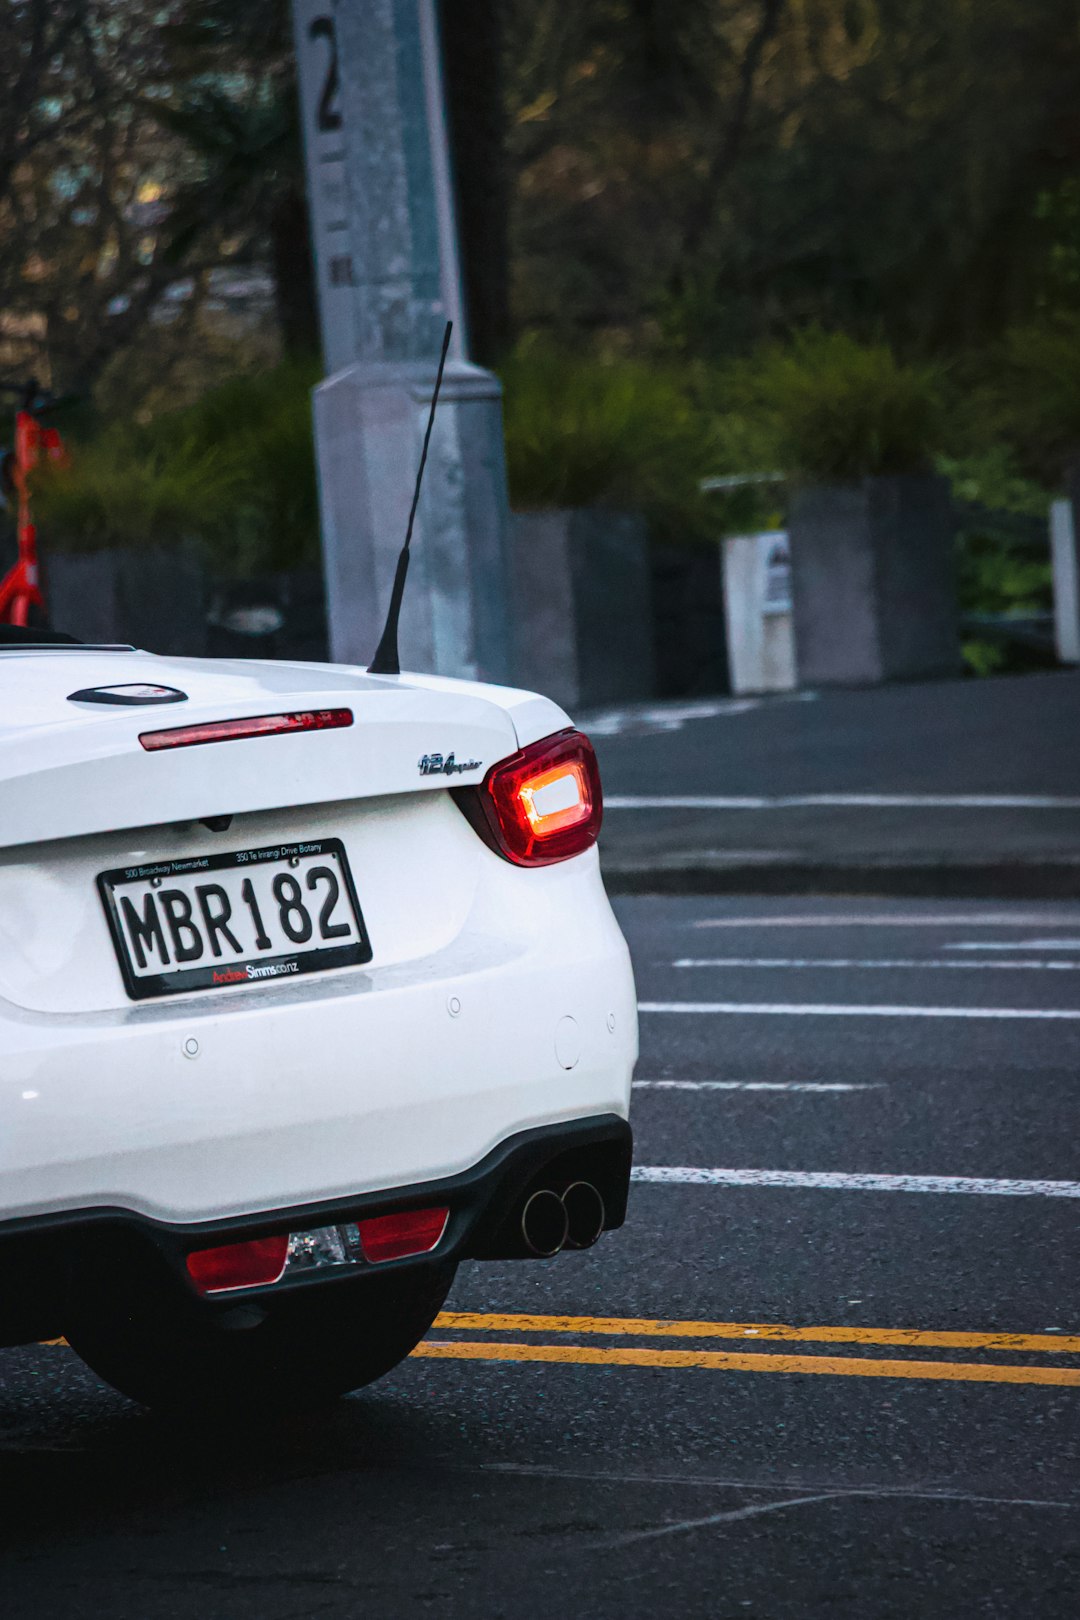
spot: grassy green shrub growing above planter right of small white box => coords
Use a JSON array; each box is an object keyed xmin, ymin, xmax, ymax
[{"xmin": 725, "ymin": 329, "xmax": 944, "ymax": 483}]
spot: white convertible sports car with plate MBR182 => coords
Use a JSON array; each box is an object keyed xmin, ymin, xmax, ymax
[{"xmin": 0, "ymin": 627, "xmax": 636, "ymax": 1406}]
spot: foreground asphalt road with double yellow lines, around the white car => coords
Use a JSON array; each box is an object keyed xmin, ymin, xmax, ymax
[{"xmin": 0, "ymin": 897, "xmax": 1080, "ymax": 1620}]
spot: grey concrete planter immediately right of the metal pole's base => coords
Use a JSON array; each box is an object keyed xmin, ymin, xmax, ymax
[{"xmin": 510, "ymin": 507, "xmax": 656, "ymax": 711}]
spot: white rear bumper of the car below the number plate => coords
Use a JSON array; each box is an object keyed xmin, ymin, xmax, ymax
[{"xmin": 0, "ymin": 855, "xmax": 636, "ymax": 1225}]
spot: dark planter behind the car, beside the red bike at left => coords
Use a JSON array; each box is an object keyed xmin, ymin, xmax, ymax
[{"xmin": 44, "ymin": 546, "xmax": 207, "ymax": 658}]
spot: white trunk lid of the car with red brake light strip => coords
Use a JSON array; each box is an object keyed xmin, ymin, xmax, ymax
[{"xmin": 0, "ymin": 648, "xmax": 524, "ymax": 847}]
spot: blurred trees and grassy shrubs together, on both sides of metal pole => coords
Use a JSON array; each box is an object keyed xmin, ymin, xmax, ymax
[{"xmin": 12, "ymin": 0, "xmax": 1080, "ymax": 670}]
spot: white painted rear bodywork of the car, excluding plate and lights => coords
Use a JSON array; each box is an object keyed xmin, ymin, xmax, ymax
[{"xmin": 0, "ymin": 646, "xmax": 636, "ymax": 1223}]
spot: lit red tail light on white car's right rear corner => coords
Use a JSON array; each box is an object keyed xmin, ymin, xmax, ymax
[{"xmin": 455, "ymin": 731, "xmax": 604, "ymax": 867}]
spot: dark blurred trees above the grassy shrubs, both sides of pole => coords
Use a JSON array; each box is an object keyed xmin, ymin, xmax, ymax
[{"xmin": 0, "ymin": 0, "xmax": 1080, "ymax": 400}]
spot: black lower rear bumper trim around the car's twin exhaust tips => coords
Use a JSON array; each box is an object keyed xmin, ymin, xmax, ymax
[{"xmin": 0, "ymin": 1115, "xmax": 633, "ymax": 1345}]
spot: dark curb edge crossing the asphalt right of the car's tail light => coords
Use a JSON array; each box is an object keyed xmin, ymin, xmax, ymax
[{"xmin": 601, "ymin": 857, "xmax": 1080, "ymax": 901}]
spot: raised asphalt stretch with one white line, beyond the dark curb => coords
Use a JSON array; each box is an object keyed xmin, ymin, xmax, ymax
[{"xmin": 585, "ymin": 671, "xmax": 1080, "ymax": 897}]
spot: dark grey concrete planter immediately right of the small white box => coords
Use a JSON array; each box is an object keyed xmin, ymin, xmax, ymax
[{"xmin": 789, "ymin": 476, "xmax": 960, "ymax": 687}]
